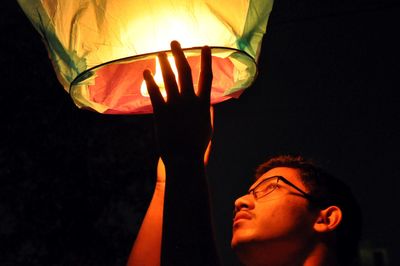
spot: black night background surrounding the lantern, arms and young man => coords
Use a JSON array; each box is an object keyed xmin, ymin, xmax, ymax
[{"xmin": 0, "ymin": 0, "xmax": 400, "ymax": 266}]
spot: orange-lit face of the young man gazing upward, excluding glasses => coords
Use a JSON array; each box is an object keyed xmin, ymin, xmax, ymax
[{"xmin": 231, "ymin": 167, "xmax": 316, "ymax": 254}]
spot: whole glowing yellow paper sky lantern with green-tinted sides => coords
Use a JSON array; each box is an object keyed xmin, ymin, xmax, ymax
[{"xmin": 18, "ymin": 0, "xmax": 273, "ymax": 114}]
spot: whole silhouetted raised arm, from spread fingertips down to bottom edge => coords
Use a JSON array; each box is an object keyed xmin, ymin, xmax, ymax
[{"xmin": 143, "ymin": 41, "xmax": 220, "ymax": 266}]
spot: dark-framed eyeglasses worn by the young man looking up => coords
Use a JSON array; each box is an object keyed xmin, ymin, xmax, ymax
[{"xmin": 248, "ymin": 176, "xmax": 316, "ymax": 201}]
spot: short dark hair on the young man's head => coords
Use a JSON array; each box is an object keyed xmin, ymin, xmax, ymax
[{"xmin": 256, "ymin": 155, "xmax": 362, "ymax": 265}]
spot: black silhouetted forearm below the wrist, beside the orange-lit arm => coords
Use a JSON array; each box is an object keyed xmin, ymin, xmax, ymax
[{"xmin": 161, "ymin": 156, "xmax": 220, "ymax": 266}]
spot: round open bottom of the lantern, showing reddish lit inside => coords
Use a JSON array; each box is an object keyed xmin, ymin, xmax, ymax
[{"xmin": 69, "ymin": 47, "xmax": 257, "ymax": 114}]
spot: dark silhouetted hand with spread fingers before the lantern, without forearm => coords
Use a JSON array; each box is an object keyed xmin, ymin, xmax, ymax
[{"xmin": 143, "ymin": 41, "xmax": 212, "ymax": 164}]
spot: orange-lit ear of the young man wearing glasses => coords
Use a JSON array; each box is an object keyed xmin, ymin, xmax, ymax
[{"xmin": 314, "ymin": 206, "xmax": 342, "ymax": 233}]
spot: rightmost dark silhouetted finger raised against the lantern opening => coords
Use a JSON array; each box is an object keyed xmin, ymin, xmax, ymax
[{"xmin": 198, "ymin": 46, "xmax": 213, "ymax": 102}]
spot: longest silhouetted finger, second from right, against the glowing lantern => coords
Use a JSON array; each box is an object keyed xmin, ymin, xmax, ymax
[{"xmin": 171, "ymin": 41, "xmax": 195, "ymax": 96}]
